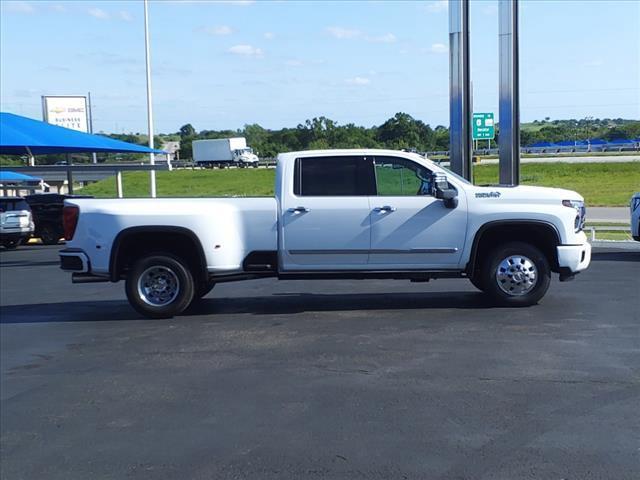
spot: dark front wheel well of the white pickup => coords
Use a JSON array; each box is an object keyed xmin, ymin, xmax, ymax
[{"xmin": 466, "ymin": 222, "xmax": 560, "ymax": 277}]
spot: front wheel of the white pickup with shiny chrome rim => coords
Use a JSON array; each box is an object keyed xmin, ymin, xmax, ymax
[{"xmin": 478, "ymin": 242, "xmax": 551, "ymax": 307}]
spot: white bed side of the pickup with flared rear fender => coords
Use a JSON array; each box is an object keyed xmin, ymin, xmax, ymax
[{"xmin": 65, "ymin": 197, "xmax": 278, "ymax": 274}]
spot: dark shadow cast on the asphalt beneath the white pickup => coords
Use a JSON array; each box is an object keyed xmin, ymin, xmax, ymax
[{"xmin": 0, "ymin": 292, "xmax": 493, "ymax": 324}]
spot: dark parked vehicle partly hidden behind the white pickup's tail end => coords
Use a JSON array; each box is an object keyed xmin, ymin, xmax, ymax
[{"xmin": 25, "ymin": 193, "xmax": 93, "ymax": 245}]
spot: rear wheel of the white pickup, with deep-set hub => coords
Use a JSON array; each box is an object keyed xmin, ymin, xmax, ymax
[{"xmin": 125, "ymin": 253, "xmax": 195, "ymax": 318}]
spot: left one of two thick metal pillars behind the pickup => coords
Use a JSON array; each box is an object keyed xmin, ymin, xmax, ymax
[{"xmin": 449, "ymin": 0, "xmax": 472, "ymax": 180}]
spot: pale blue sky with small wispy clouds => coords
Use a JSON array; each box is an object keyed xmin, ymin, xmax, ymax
[{"xmin": 0, "ymin": 0, "xmax": 640, "ymax": 133}]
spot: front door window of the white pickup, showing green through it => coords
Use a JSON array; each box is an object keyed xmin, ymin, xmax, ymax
[{"xmin": 375, "ymin": 157, "xmax": 432, "ymax": 196}]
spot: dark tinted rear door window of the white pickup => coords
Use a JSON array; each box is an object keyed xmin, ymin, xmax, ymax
[{"xmin": 293, "ymin": 157, "xmax": 375, "ymax": 197}]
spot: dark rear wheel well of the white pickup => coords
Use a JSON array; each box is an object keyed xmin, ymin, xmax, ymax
[{"xmin": 109, "ymin": 227, "xmax": 208, "ymax": 282}]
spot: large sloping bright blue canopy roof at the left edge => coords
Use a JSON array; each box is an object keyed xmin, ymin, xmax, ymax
[{"xmin": 0, "ymin": 112, "xmax": 164, "ymax": 155}]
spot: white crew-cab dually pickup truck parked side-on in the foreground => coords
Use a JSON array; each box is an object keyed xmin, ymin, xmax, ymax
[{"xmin": 60, "ymin": 150, "xmax": 591, "ymax": 318}]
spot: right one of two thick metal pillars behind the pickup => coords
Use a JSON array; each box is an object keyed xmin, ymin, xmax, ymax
[{"xmin": 498, "ymin": 0, "xmax": 520, "ymax": 185}]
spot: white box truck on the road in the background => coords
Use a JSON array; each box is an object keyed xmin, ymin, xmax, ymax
[{"xmin": 192, "ymin": 137, "xmax": 258, "ymax": 168}]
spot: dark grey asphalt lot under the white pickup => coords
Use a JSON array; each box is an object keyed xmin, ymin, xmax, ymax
[{"xmin": 0, "ymin": 246, "xmax": 640, "ymax": 480}]
